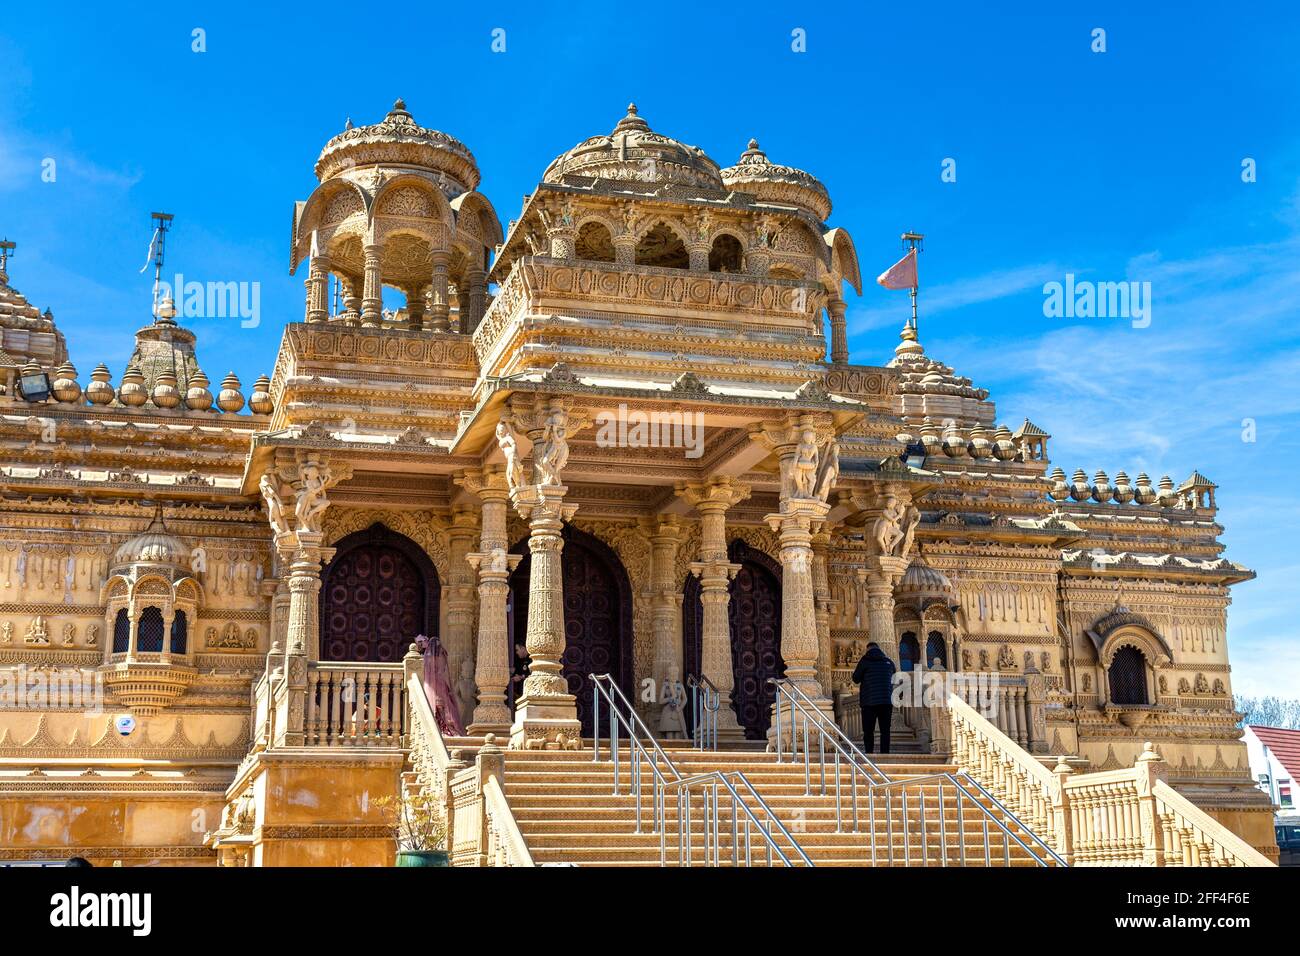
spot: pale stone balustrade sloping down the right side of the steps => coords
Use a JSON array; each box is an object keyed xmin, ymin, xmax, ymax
[{"xmin": 948, "ymin": 695, "xmax": 1274, "ymax": 866}]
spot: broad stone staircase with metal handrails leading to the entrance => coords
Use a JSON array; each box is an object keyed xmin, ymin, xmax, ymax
[{"xmin": 503, "ymin": 744, "xmax": 1055, "ymax": 866}]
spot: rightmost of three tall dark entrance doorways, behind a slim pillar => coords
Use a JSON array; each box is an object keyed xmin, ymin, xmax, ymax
[{"xmin": 681, "ymin": 540, "xmax": 785, "ymax": 740}]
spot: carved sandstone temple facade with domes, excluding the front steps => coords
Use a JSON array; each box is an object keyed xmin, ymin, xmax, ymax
[{"xmin": 0, "ymin": 101, "xmax": 1253, "ymax": 862}]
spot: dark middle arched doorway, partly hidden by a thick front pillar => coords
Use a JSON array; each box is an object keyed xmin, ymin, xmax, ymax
[{"xmin": 507, "ymin": 524, "xmax": 636, "ymax": 736}]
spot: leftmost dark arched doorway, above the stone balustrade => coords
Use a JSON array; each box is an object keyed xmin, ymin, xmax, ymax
[{"xmin": 320, "ymin": 524, "xmax": 439, "ymax": 663}]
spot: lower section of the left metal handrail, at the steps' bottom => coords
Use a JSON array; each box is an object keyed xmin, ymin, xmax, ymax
[{"xmin": 659, "ymin": 770, "xmax": 814, "ymax": 866}]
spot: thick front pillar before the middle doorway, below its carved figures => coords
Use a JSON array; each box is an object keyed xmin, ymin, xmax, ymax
[{"xmin": 510, "ymin": 484, "xmax": 582, "ymax": 749}]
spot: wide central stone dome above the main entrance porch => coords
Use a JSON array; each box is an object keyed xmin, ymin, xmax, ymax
[{"xmin": 542, "ymin": 103, "xmax": 725, "ymax": 190}]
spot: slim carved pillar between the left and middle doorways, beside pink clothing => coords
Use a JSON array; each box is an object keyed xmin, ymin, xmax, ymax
[{"xmin": 456, "ymin": 468, "xmax": 523, "ymax": 736}]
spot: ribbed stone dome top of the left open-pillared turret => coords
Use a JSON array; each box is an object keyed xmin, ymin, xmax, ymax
[{"xmin": 316, "ymin": 100, "xmax": 478, "ymax": 193}]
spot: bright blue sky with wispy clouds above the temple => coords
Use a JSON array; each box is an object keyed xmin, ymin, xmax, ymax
[{"xmin": 0, "ymin": 1, "xmax": 1300, "ymax": 696}]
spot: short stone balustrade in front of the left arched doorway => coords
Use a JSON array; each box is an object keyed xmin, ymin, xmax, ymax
[{"xmin": 303, "ymin": 663, "xmax": 407, "ymax": 747}]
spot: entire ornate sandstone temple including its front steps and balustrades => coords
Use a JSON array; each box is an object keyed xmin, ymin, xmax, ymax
[{"xmin": 0, "ymin": 100, "xmax": 1277, "ymax": 866}]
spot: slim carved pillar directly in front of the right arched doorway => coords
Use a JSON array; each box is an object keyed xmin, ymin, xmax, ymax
[{"xmin": 677, "ymin": 475, "xmax": 750, "ymax": 739}]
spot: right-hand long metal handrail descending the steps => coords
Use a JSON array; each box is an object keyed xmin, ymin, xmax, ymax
[{"xmin": 768, "ymin": 678, "xmax": 1066, "ymax": 866}]
